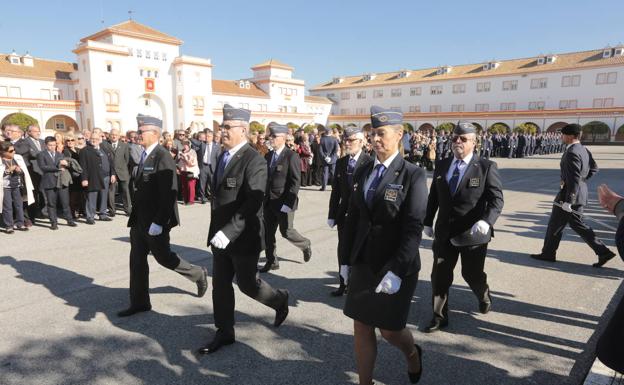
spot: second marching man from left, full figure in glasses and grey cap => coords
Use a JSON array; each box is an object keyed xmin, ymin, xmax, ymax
[{"xmin": 199, "ymin": 104, "xmax": 288, "ymax": 354}]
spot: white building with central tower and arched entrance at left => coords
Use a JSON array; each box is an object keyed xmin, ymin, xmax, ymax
[{"xmin": 0, "ymin": 20, "xmax": 331, "ymax": 133}]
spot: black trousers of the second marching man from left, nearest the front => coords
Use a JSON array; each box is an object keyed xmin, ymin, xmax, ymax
[{"xmin": 212, "ymin": 248, "xmax": 286, "ymax": 336}]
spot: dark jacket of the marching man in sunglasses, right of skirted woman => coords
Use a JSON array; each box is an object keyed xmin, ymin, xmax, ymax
[{"xmin": 425, "ymin": 155, "xmax": 504, "ymax": 241}]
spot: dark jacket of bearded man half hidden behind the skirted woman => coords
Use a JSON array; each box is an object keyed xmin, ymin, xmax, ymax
[{"xmin": 327, "ymin": 150, "xmax": 373, "ymax": 225}]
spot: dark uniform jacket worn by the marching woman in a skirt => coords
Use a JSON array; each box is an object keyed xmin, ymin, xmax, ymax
[{"xmin": 339, "ymin": 156, "xmax": 427, "ymax": 278}]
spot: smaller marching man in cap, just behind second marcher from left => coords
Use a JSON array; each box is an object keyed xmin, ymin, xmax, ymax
[{"xmin": 260, "ymin": 123, "xmax": 312, "ymax": 273}]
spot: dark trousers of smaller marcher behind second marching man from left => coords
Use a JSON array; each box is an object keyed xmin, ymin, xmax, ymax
[{"xmin": 264, "ymin": 204, "xmax": 310, "ymax": 261}]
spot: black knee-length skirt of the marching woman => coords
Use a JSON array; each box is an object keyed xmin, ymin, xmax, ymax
[{"xmin": 344, "ymin": 264, "xmax": 418, "ymax": 330}]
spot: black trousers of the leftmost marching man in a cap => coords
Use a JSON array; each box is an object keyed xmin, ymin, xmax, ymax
[{"xmin": 130, "ymin": 225, "xmax": 180, "ymax": 307}]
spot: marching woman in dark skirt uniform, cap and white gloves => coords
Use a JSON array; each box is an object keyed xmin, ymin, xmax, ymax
[{"xmin": 340, "ymin": 106, "xmax": 427, "ymax": 385}]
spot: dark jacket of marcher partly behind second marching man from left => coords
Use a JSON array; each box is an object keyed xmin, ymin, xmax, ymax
[{"xmin": 264, "ymin": 147, "xmax": 301, "ymax": 211}]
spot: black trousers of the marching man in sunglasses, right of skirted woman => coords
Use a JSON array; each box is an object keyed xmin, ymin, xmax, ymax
[{"xmin": 431, "ymin": 240, "xmax": 490, "ymax": 320}]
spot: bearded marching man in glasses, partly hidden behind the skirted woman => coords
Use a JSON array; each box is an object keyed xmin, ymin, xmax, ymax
[{"xmin": 327, "ymin": 128, "xmax": 372, "ymax": 297}]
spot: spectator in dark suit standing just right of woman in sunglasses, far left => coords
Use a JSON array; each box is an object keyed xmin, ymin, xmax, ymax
[{"xmin": 37, "ymin": 136, "xmax": 76, "ymax": 230}]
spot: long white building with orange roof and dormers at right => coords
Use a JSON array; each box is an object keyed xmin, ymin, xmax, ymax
[{"xmin": 310, "ymin": 46, "xmax": 624, "ymax": 141}]
